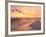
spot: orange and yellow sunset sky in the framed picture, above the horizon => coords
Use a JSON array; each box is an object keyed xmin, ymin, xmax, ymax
[{"xmin": 11, "ymin": 6, "xmax": 41, "ymax": 18}]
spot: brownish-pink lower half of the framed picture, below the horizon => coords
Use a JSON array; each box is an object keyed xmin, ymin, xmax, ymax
[{"xmin": 11, "ymin": 18, "xmax": 41, "ymax": 31}]
